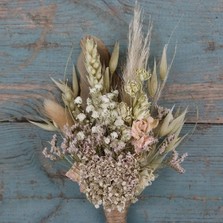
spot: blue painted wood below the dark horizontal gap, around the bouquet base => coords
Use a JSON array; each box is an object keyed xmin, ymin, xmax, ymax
[{"xmin": 0, "ymin": 123, "xmax": 223, "ymax": 223}]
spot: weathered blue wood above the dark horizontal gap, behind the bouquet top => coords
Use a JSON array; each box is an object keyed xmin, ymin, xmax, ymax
[{"xmin": 0, "ymin": 0, "xmax": 223, "ymax": 123}]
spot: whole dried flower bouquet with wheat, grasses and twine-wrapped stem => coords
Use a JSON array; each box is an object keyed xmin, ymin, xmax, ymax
[{"xmin": 32, "ymin": 3, "xmax": 187, "ymax": 223}]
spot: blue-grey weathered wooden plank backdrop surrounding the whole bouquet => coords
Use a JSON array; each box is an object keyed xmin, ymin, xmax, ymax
[{"xmin": 0, "ymin": 0, "xmax": 223, "ymax": 223}]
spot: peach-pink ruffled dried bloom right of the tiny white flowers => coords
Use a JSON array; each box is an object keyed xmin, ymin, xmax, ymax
[{"xmin": 131, "ymin": 117, "xmax": 159, "ymax": 153}]
